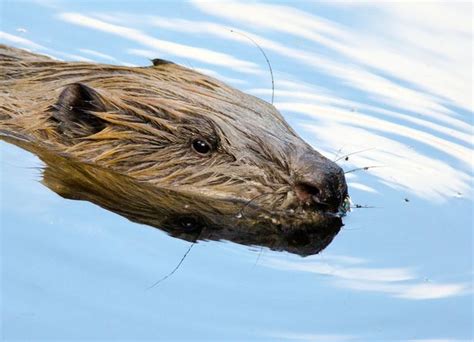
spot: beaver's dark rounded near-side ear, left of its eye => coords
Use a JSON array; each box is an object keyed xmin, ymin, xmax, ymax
[{"xmin": 53, "ymin": 83, "xmax": 107, "ymax": 138}]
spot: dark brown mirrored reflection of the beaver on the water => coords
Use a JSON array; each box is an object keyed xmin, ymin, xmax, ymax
[{"xmin": 1, "ymin": 135, "xmax": 343, "ymax": 256}]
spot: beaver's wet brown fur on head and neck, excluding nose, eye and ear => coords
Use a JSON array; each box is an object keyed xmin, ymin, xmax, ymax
[{"xmin": 0, "ymin": 46, "xmax": 318, "ymax": 208}]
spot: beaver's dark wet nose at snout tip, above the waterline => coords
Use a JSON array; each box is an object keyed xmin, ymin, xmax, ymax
[{"xmin": 294, "ymin": 151, "xmax": 347, "ymax": 212}]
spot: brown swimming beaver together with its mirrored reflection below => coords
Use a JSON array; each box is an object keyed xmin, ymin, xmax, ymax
[{"xmin": 0, "ymin": 45, "xmax": 348, "ymax": 255}]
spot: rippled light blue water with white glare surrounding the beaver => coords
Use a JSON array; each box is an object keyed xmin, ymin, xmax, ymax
[{"xmin": 0, "ymin": 1, "xmax": 473, "ymax": 341}]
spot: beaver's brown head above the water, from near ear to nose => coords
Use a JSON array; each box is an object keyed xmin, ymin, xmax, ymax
[{"xmin": 50, "ymin": 63, "xmax": 347, "ymax": 212}]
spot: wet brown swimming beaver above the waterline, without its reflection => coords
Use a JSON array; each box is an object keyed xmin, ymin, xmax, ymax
[{"xmin": 0, "ymin": 45, "xmax": 347, "ymax": 254}]
